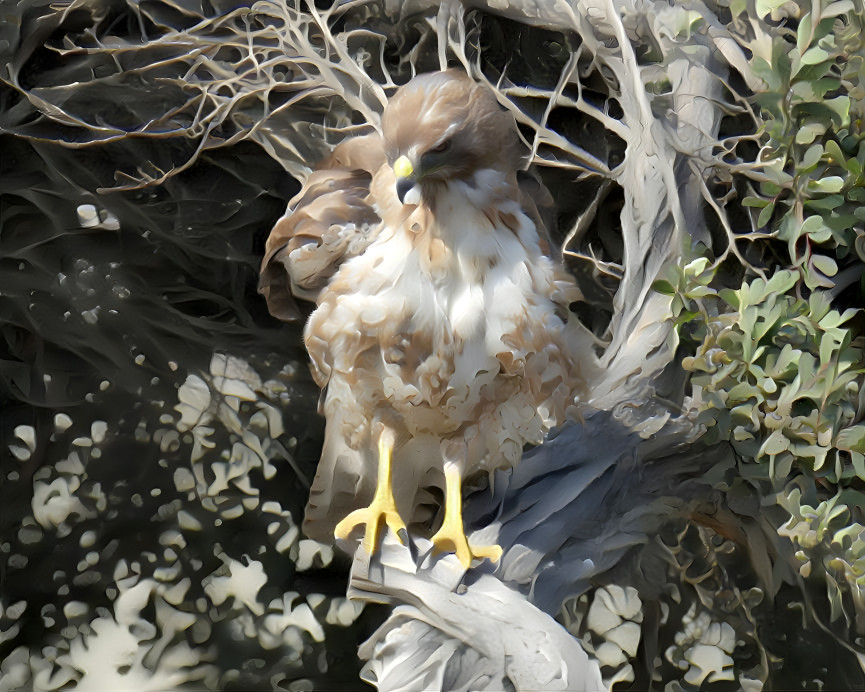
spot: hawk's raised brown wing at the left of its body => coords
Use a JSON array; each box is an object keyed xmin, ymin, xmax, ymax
[{"xmin": 258, "ymin": 133, "xmax": 385, "ymax": 321}]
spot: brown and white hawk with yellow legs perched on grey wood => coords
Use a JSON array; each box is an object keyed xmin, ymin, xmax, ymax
[{"xmin": 260, "ymin": 70, "xmax": 582, "ymax": 568}]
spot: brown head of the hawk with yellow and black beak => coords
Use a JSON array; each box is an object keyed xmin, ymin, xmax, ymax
[{"xmin": 382, "ymin": 70, "xmax": 526, "ymax": 204}]
